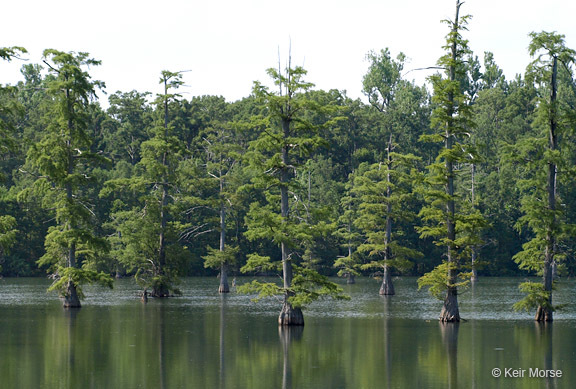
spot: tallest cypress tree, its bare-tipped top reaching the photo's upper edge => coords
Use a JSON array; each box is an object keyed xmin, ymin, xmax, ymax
[{"xmin": 418, "ymin": 0, "xmax": 474, "ymax": 322}]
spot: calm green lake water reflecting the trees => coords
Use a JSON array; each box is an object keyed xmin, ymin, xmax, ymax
[{"xmin": 0, "ymin": 278, "xmax": 576, "ymax": 389}]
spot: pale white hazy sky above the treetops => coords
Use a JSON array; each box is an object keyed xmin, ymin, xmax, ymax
[{"xmin": 0, "ymin": 0, "xmax": 576, "ymax": 104}]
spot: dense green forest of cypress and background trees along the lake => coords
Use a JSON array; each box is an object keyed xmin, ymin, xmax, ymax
[{"xmin": 0, "ymin": 4, "xmax": 576, "ymax": 321}]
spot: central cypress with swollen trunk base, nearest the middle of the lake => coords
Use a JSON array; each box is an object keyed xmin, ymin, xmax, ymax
[{"xmin": 241, "ymin": 64, "xmax": 341, "ymax": 326}]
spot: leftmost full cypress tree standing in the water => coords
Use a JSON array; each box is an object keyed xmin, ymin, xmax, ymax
[{"xmin": 27, "ymin": 49, "xmax": 112, "ymax": 308}]
